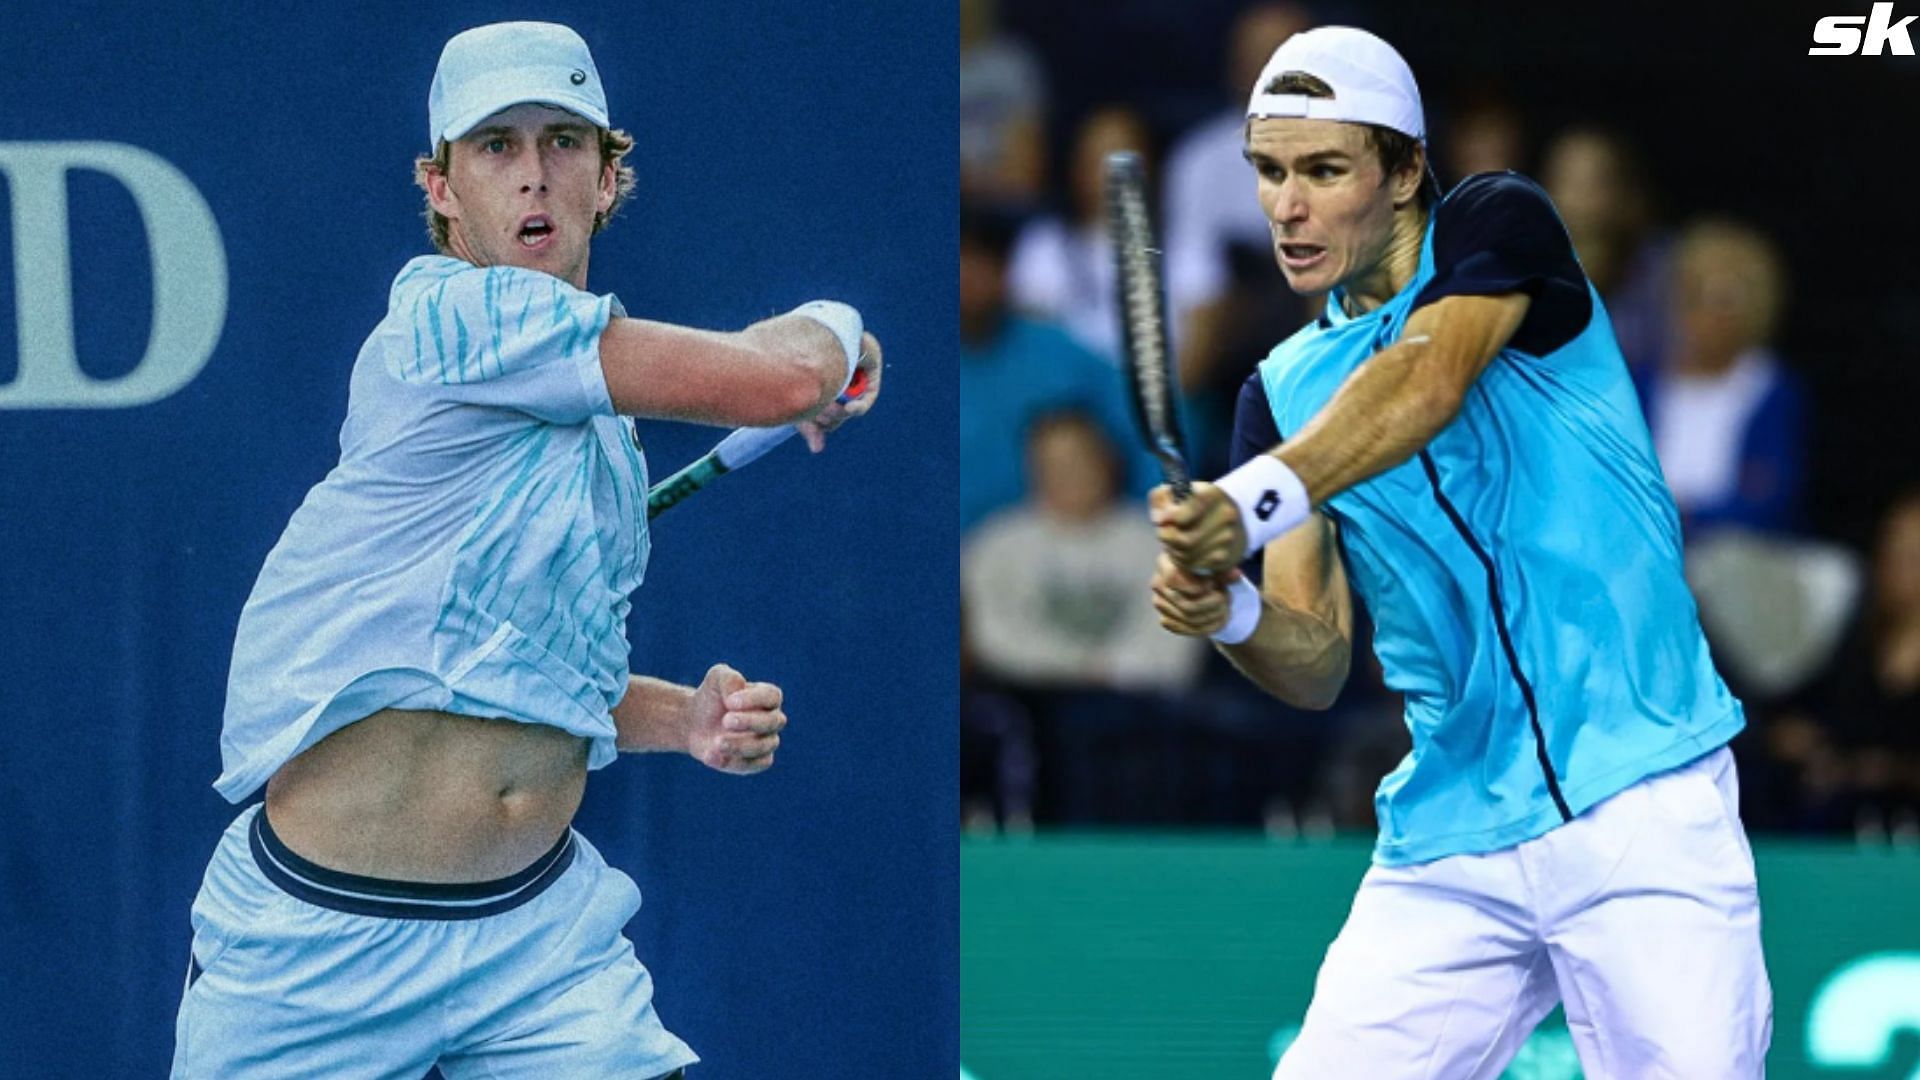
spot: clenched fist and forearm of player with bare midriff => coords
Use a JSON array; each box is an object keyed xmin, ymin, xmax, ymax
[{"xmin": 612, "ymin": 663, "xmax": 787, "ymax": 774}]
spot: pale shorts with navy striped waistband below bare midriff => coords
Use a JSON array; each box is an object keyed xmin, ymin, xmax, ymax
[{"xmin": 173, "ymin": 805, "xmax": 697, "ymax": 1080}]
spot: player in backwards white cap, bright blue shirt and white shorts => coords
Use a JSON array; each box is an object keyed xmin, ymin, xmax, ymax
[{"xmin": 1152, "ymin": 27, "xmax": 1772, "ymax": 1080}]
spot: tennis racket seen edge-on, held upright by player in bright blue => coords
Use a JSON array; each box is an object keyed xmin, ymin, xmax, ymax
[{"xmin": 1106, "ymin": 152, "xmax": 1192, "ymax": 502}]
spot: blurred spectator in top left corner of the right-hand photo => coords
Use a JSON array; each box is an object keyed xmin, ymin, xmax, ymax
[{"xmin": 960, "ymin": 0, "xmax": 1046, "ymax": 206}]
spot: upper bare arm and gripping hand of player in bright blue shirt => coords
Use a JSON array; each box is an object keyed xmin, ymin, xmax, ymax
[{"xmin": 1154, "ymin": 292, "xmax": 1530, "ymax": 573}]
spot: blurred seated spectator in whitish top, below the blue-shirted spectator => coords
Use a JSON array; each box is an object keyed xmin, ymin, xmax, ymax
[{"xmin": 960, "ymin": 409, "xmax": 1208, "ymax": 818}]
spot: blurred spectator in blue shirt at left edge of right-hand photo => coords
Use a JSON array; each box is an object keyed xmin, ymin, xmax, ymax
[{"xmin": 960, "ymin": 206, "xmax": 1152, "ymax": 532}]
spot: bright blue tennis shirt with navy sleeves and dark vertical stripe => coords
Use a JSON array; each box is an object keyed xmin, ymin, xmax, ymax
[{"xmin": 1235, "ymin": 173, "xmax": 1743, "ymax": 865}]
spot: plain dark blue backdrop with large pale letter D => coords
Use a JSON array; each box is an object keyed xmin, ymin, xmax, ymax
[{"xmin": 0, "ymin": 0, "xmax": 958, "ymax": 1080}]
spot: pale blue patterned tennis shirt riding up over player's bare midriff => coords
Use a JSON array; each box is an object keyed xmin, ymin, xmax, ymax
[{"xmin": 213, "ymin": 256, "xmax": 647, "ymax": 803}]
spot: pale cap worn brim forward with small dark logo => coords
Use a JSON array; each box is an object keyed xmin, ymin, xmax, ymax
[{"xmin": 426, "ymin": 23, "xmax": 609, "ymax": 146}]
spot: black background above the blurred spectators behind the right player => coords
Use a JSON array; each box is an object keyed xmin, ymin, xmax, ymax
[{"xmin": 998, "ymin": 0, "xmax": 1920, "ymax": 544}]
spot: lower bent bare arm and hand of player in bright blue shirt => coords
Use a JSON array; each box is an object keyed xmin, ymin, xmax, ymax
[{"xmin": 1152, "ymin": 492, "xmax": 1354, "ymax": 709}]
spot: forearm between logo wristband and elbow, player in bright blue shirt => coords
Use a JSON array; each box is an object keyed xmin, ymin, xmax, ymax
[{"xmin": 1273, "ymin": 334, "xmax": 1461, "ymax": 505}]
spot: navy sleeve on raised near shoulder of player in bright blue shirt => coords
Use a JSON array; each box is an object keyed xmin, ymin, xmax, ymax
[{"xmin": 1413, "ymin": 173, "xmax": 1594, "ymax": 356}]
